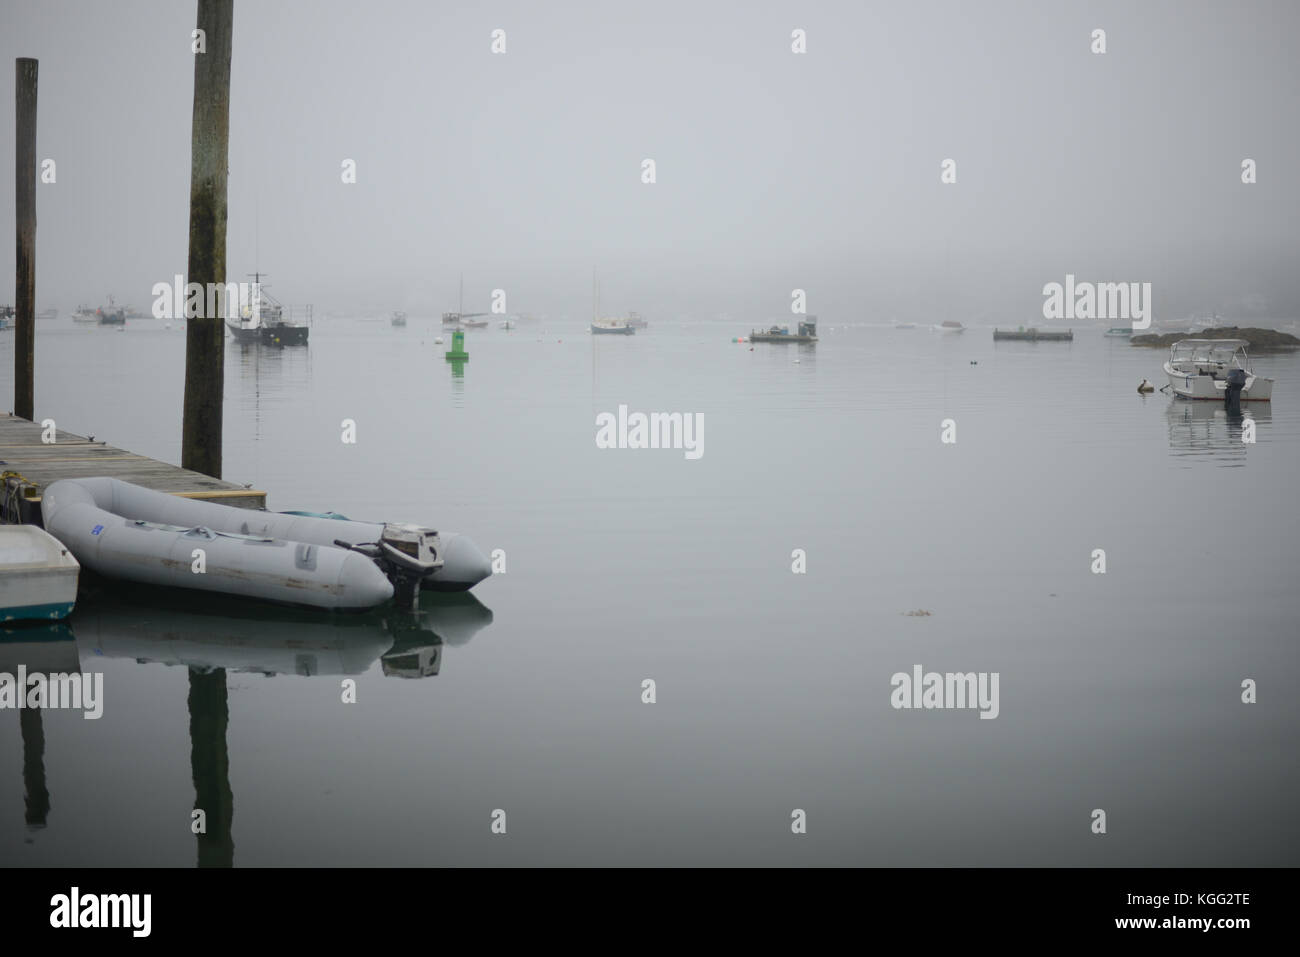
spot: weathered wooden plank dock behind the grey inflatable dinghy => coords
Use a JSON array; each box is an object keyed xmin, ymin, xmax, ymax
[{"xmin": 0, "ymin": 415, "xmax": 267, "ymax": 525}]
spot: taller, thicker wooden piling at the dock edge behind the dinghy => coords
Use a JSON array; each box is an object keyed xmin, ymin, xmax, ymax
[{"xmin": 181, "ymin": 0, "xmax": 234, "ymax": 479}]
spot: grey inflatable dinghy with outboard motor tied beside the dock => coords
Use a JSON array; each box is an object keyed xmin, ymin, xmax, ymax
[{"xmin": 42, "ymin": 479, "xmax": 491, "ymax": 609}]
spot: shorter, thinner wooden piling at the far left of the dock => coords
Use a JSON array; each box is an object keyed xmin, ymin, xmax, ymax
[{"xmin": 13, "ymin": 57, "xmax": 38, "ymax": 420}]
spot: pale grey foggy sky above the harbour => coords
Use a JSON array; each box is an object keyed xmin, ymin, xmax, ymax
[{"xmin": 0, "ymin": 0, "xmax": 1300, "ymax": 322}]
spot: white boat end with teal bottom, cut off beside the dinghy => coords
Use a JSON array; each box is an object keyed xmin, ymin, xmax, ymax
[{"xmin": 0, "ymin": 525, "xmax": 81, "ymax": 622}]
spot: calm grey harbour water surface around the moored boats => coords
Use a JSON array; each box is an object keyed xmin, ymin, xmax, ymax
[{"xmin": 0, "ymin": 317, "xmax": 1300, "ymax": 866}]
